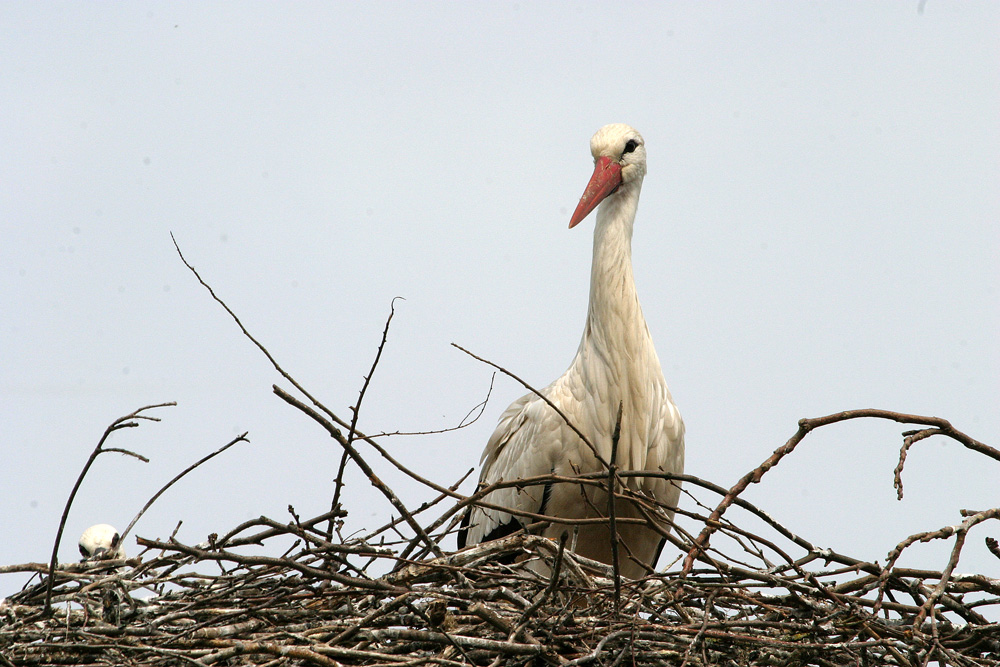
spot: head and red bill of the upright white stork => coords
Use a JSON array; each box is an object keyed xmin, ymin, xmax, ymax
[{"xmin": 569, "ymin": 123, "xmax": 646, "ymax": 229}]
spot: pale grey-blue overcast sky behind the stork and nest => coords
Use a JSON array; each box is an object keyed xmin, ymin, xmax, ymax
[{"xmin": 0, "ymin": 0, "xmax": 1000, "ymax": 594}]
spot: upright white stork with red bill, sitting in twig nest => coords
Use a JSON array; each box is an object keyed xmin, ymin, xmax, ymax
[{"xmin": 458, "ymin": 124, "xmax": 684, "ymax": 579}]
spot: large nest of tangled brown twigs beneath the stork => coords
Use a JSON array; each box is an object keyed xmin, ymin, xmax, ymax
[{"xmin": 0, "ymin": 247, "xmax": 1000, "ymax": 667}]
